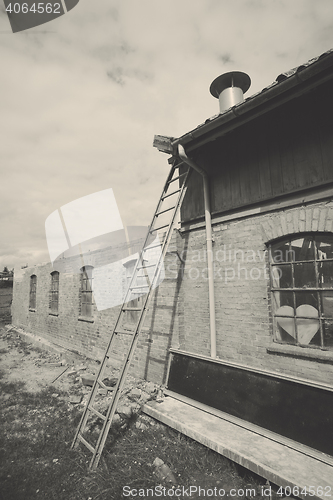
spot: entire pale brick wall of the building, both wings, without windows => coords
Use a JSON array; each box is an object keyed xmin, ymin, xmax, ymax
[{"xmin": 12, "ymin": 202, "xmax": 333, "ymax": 385}]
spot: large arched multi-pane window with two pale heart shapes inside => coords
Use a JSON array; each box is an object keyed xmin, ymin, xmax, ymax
[{"xmin": 269, "ymin": 233, "xmax": 333, "ymax": 350}]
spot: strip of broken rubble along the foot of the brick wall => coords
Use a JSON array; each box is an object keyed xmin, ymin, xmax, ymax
[{"xmin": 0, "ymin": 325, "xmax": 159, "ymax": 421}]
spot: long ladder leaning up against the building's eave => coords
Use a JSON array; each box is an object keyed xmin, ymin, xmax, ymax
[{"xmin": 71, "ymin": 161, "xmax": 191, "ymax": 469}]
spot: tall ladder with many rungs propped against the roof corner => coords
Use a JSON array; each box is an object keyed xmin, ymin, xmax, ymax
[{"xmin": 71, "ymin": 161, "xmax": 191, "ymax": 470}]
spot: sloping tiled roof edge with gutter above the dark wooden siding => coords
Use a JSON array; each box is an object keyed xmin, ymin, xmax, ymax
[{"xmin": 154, "ymin": 49, "xmax": 333, "ymax": 154}]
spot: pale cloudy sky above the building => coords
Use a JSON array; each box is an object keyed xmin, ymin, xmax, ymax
[{"xmin": 0, "ymin": 0, "xmax": 333, "ymax": 270}]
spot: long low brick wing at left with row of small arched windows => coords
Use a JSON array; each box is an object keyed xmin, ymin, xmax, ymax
[{"xmin": 12, "ymin": 230, "xmax": 179, "ymax": 383}]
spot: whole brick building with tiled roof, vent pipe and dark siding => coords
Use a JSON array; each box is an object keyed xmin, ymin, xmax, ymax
[{"xmin": 12, "ymin": 51, "xmax": 333, "ymax": 464}]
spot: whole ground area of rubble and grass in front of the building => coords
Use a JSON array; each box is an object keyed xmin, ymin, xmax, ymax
[{"xmin": 0, "ymin": 325, "xmax": 262, "ymax": 500}]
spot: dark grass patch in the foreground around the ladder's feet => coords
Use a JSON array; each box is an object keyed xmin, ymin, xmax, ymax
[{"xmin": 0, "ymin": 358, "xmax": 262, "ymax": 500}]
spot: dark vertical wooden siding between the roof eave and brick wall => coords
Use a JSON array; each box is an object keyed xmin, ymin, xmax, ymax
[{"xmin": 182, "ymin": 79, "xmax": 333, "ymax": 221}]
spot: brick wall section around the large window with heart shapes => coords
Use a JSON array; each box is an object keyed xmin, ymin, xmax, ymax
[{"xmin": 173, "ymin": 202, "xmax": 333, "ymax": 386}]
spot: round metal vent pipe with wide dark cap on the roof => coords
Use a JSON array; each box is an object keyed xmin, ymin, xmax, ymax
[{"xmin": 209, "ymin": 71, "xmax": 251, "ymax": 113}]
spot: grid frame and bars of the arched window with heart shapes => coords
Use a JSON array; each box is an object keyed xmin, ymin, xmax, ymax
[{"xmin": 267, "ymin": 232, "xmax": 333, "ymax": 353}]
